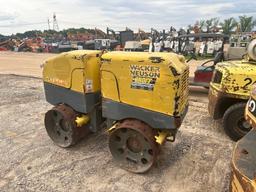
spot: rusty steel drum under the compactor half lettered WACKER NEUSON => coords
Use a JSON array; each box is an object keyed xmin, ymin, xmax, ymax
[{"xmin": 109, "ymin": 119, "xmax": 159, "ymax": 173}]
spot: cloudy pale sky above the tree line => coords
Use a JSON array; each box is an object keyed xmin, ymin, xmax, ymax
[{"xmin": 0, "ymin": 0, "xmax": 256, "ymax": 35}]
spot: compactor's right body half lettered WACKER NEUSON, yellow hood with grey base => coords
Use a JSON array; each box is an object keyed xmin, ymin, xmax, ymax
[{"xmin": 101, "ymin": 52, "xmax": 189, "ymax": 128}]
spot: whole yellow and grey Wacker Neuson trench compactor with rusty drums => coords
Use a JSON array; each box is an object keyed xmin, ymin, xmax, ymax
[{"xmin": 43, "ymin": 50, "xmax": 189, "ymax": 173}]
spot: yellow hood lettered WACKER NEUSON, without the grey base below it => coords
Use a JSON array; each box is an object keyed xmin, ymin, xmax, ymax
[{"xmin": 101, "ymin": 52, "xmax": 188, "ymax": 116}]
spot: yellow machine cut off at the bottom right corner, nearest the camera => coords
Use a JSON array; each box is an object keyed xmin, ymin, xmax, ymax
[{"xmin": 230, "ymin": 86, "xmax": 256, "ymax": 192}]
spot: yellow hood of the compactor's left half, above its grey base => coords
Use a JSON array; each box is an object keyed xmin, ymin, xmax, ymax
[{"xmin": 43, "ymin": 50, "xmax": 102, "ymax": 93}]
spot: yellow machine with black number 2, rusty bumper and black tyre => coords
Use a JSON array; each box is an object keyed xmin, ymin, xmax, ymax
[{"xmin": 208, "ymin": 39, "xmax": 256, "ymax": 141}]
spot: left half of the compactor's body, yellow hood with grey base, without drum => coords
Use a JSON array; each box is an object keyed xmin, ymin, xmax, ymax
[{"xmin": 43, "ymin": 50, "xmax": 102, "ymax": 132}]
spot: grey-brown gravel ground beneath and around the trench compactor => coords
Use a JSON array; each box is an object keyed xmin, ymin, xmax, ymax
[{"xmin": 0, "ymin": 75, "xmax": 233, "ymax": 192}]
